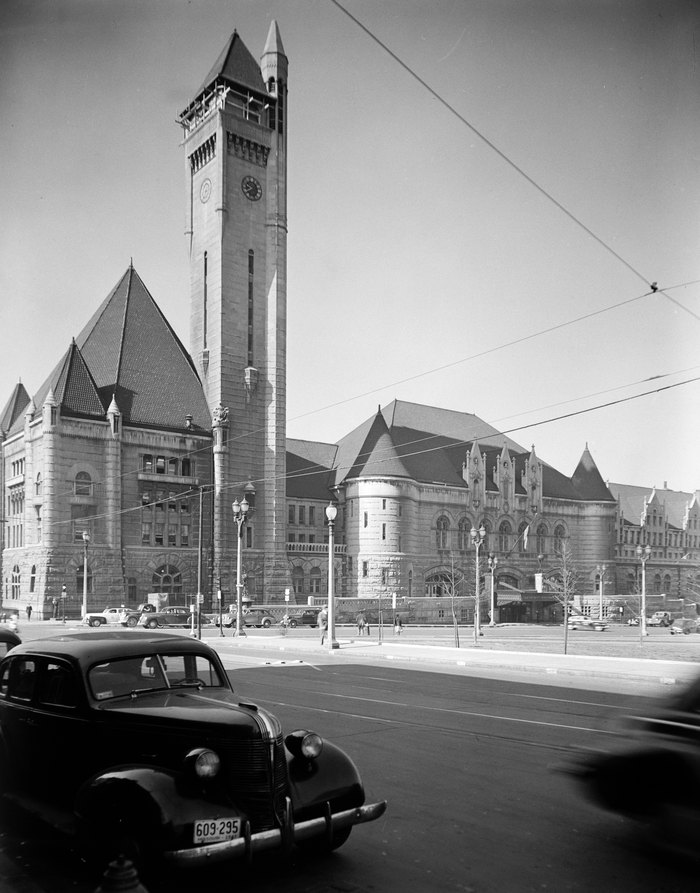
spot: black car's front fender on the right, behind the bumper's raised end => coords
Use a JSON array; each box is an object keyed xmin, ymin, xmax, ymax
[{"xmin": 286, "ymin": 739, "xmax": 365, "ymax": 816}]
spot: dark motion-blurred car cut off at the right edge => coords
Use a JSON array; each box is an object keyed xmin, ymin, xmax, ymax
[{"xmin": 563, "ymin": 677, "xmax": 700, "ymax": 858}]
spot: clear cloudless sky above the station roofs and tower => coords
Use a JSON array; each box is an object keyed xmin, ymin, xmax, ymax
[{"xmin": 0, "ymin": 0, "xmax": 700, "ymax": 491}]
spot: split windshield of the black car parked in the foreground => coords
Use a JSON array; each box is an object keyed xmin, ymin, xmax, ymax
[{"xmin": 88, "ymin": 654, "xmax": 226, "ymax": 701}]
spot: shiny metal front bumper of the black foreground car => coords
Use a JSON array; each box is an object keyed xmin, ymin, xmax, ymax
[{"xmin": 164, "ymin": 800, "xmax": 386, "ymax": 867}]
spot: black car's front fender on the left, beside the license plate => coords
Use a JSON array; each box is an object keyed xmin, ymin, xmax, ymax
[{"xmin": 74, "ymin": 766, "xmax": 245, "ymax": 852}]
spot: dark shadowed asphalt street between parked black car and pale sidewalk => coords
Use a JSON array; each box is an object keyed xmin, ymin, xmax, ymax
[{"xmin": 0, "ymin": 644, "xmax": 697, "ymax": 893}]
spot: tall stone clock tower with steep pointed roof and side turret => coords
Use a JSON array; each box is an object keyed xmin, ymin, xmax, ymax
[{"xmin": 180, "ymin": 21, "xmax": 289, "ymax": 600}]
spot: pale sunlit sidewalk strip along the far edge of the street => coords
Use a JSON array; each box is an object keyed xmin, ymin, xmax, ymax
[{"xmin": 212, "ymin": 636, "xmax": 700, "ymax": 694}]
